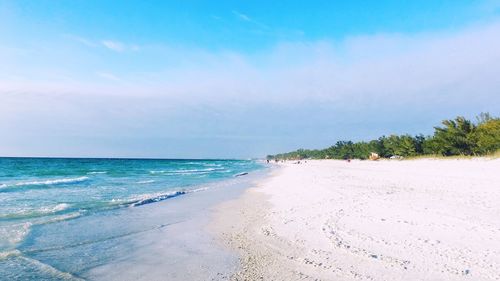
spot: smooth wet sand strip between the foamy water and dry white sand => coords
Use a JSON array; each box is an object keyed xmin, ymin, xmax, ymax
[{"xmin": 85, "ymin": 170, "xmax": 272, "ymax": 280}]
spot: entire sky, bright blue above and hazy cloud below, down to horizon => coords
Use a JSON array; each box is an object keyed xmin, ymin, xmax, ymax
[{"xmin": 0, "ymin": 0, "xmax": 500, "ymax": 158}]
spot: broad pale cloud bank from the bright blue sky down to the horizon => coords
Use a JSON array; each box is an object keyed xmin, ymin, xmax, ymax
[{"xmin": 0, "ymin": 20, "xmax": 500, "ymax": 157}]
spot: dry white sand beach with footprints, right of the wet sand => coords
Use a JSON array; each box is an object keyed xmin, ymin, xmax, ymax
[{"xmin": 212, "ymin": 159, "xmax": 500, "ymax": 280}]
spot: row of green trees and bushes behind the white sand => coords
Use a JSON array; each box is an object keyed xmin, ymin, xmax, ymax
[{"xmin": 267, "ymin": 113, "xmax": 500, "ymax": 159}]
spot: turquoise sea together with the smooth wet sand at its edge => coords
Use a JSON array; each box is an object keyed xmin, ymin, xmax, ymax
[{"xmin": 0, "ymin": 158, "xmax": 263, "ymax": 280}]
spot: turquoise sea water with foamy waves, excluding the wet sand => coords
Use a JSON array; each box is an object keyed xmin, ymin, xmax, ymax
[{"xmin": 0, "ymin": 158, "xmax": 262, "ymax": 280}]
